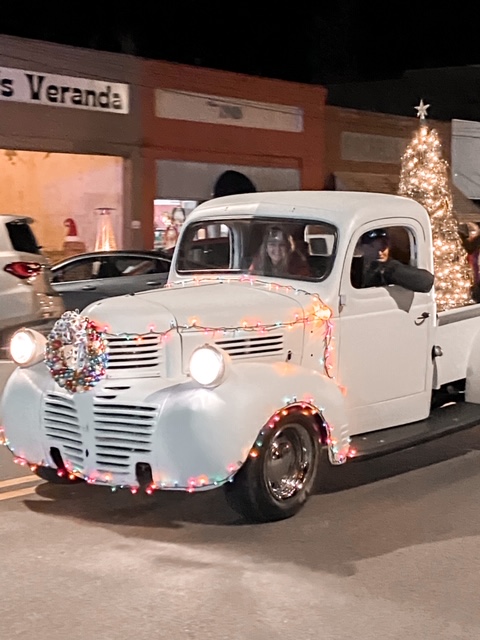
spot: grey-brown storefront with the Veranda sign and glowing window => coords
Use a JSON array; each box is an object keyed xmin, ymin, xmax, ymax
[{"xmin": 0, "ymin": 35, "xmax": 141, "ymax": 260}]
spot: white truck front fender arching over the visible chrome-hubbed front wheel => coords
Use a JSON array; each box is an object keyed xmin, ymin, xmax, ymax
[{"xmin": 148, "ymin": 363, "xmax": 349, "ymax": 483}]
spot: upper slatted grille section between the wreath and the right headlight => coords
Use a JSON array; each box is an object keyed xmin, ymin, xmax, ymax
[{"xmin": 107, "ymin": 334, "xmax": 163, "ymax": 377}]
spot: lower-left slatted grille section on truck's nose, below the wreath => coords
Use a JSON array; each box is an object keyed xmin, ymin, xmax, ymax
[{"xmin": 43, "ymin": 393, "xmax": 83, "ymax": 468}]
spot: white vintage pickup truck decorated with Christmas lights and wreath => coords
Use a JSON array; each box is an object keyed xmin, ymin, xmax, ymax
[{"xmin": 2, "ymin": 191, "xmax": 480, "ymax": 522}]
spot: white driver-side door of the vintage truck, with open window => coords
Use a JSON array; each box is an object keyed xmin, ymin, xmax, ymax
[{"xmin": 337, "ymin": 219, "xmax": 436, "ymax": 433}]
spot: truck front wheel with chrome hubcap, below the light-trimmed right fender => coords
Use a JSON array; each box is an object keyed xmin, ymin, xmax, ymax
[{"xmin": 224, "ymin": 413, "xmax": 320, "ymax": 522}]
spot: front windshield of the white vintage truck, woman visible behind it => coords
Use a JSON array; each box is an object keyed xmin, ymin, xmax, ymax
[{"xmin": 176, "ymin": 217, "xmax": 338, "ymax": 280}]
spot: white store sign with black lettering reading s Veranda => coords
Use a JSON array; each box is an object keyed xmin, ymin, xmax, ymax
[{"xmin": 0, "ymin": 67, "xmax": 129, "ymax": 113}]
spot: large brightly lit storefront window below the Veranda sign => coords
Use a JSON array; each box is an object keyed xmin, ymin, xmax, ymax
[{"xmin": 0, "ymin": 149, "xmax": 125, "ymax": 263}]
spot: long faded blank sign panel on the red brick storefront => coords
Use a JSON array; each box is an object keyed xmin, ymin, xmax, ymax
[{"xmin": 155, "ymin": 89, "xmax": 303, "ymax": 133}]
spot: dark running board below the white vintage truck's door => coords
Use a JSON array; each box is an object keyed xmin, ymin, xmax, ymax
[{"xmin": 351, "ymin": 402, "xmax": 480, "ymax": 461}]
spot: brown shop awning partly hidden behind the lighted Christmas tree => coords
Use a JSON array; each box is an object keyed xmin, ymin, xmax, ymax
[{"xmin": 334, "ymin": 171, "xmax": 480, "ymax": 222}]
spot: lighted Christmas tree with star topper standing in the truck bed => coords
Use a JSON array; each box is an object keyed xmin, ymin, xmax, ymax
[{"xmin": 398, "ymin": 100, "xmax": 473, "ymax": 311}]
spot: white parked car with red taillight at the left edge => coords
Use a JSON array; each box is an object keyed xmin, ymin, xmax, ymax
[{"xmin": 0, "ymin": 214, "xmax": 65, "ymax": 390}]
